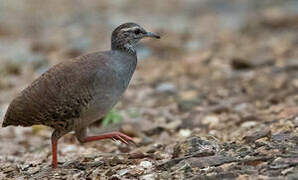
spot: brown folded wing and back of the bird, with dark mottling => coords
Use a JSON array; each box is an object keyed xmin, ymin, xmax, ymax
[{"xmin": 2, "ymin": 53, "xmax": 107, "ymax": 127}]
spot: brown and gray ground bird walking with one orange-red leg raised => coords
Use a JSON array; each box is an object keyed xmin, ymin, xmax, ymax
[{"xmin": 2, "ymin": 22, "xmax": 160, "ymax": 168}]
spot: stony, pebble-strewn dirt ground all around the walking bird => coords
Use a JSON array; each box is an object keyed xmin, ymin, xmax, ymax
[{"xmin": 0, "ymin": 0, "xmax": 298, "ymax": 180}]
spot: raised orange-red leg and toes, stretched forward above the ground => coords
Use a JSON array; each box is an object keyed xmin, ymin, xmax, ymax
[{"xmin": 84, "ymin": 132, "xmax": 135, "ymax": 144}]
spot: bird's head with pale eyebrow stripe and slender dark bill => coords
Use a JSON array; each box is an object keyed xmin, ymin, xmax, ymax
[{"xmin": 112, "ymin": 23, "xmax": 160, "ymax": 53}]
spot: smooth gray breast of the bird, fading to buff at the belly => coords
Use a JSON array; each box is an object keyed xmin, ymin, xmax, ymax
[{"xmin": 80, "ymin": 51, "xmax": 137, "ymax": 126}]
